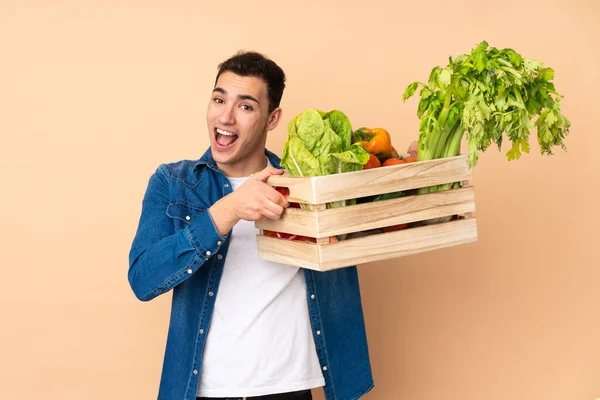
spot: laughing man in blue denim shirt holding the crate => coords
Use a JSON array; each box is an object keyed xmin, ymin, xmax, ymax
[{"xmin": 128, "ymin": 52, "xmax": 373, "ymax": 400}]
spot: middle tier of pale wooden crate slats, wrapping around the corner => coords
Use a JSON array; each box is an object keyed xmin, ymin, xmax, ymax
[{"xmin": 256, "ymin": 187, "xmax": 475, "ymax": 238}]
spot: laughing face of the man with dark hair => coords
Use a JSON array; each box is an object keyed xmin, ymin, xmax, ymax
[{"xmin": 206, "ymin": 71, "xmax": 281, "ymax": 177}]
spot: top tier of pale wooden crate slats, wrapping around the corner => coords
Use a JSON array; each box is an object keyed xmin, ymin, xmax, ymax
[{"xmin": 267, "ymin": 155, "xmax": 472, "ymax": 204}]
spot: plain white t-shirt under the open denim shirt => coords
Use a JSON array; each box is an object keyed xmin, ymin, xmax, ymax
[{"xmin": 198, "ymin": 173, "xmax": 325, "ymax": 397}]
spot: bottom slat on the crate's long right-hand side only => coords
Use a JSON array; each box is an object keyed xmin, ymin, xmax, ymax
[{"xmin": 320, "ymin": 218, "xmax": 477, "ymax": 270}]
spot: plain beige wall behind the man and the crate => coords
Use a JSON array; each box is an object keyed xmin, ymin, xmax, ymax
[{"xmin": 0, "ymin": 0, "xmax": 600, "ymax": 400}]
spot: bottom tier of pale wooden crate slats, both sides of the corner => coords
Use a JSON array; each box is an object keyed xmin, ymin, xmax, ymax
[{"xmin": 257, "ymin": 218, "xmax": 477, "ymax": 271}]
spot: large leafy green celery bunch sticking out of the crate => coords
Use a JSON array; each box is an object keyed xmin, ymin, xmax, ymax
[{"xmin": 403, "ymin": 41, "xmax": 571, "ymax": 193}]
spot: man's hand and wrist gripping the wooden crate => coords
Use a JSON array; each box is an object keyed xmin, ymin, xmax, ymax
[{"xmin": 208, "ymin": 167, "xmax": 289, "ymax": 236}]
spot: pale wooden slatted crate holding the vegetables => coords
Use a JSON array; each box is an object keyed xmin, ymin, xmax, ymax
[{"xmin": 256, "ymin": 155, "xmax": 477, "ymax": 271}]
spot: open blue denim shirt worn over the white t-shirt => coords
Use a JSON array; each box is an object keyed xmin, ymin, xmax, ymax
[{"xmin": 128, "ymin": 149, "xmax": 373, "ymax": 400}]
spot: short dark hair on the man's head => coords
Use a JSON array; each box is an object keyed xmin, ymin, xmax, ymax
[{"xmin": 215, "ymin": 51, "xmax": 285, "ymax": 112}]
